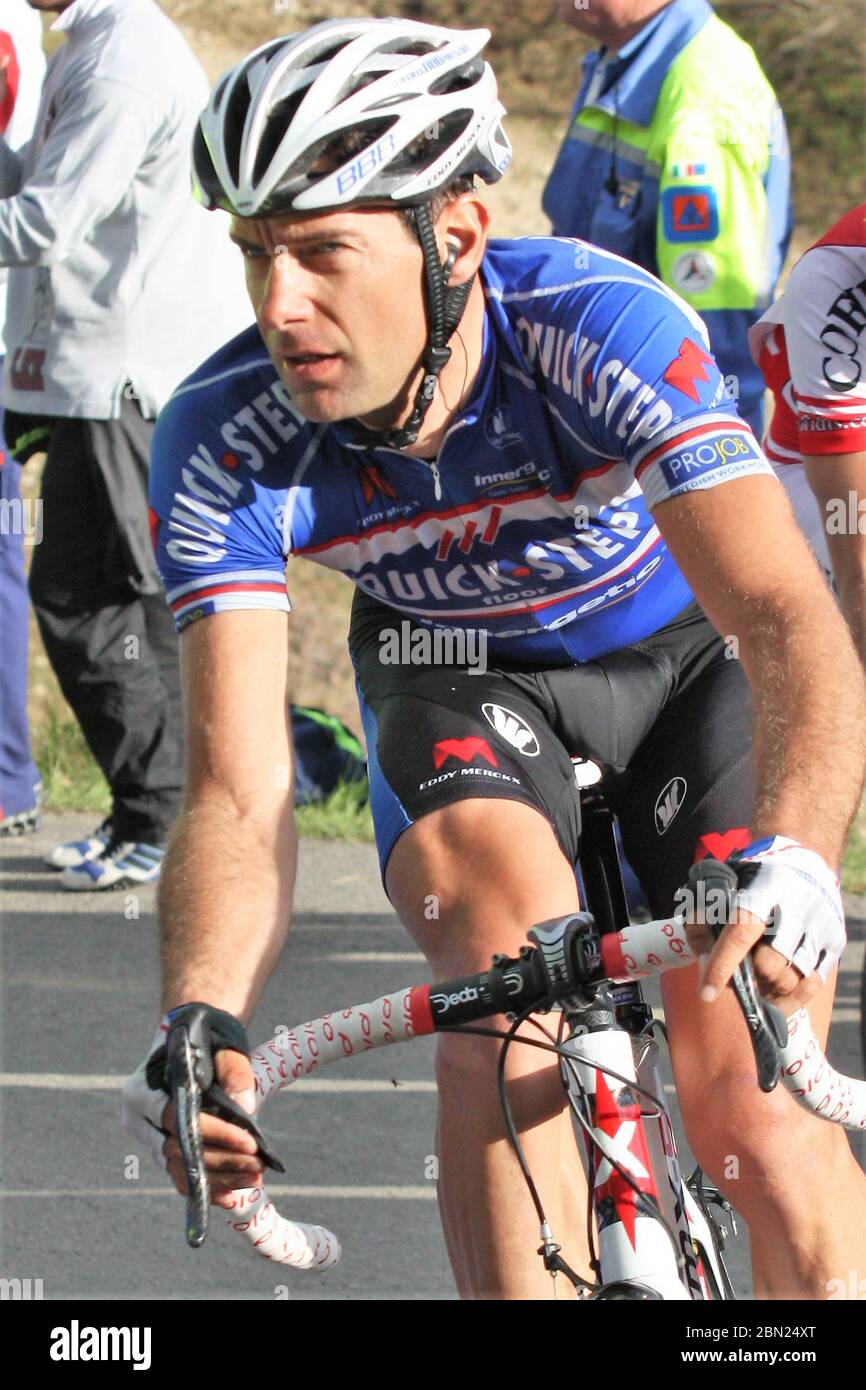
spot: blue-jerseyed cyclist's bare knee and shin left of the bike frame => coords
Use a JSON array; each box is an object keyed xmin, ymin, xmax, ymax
[{"xmin": 386, "ymin": 798, "xmax": 587, "ymax": 1298}]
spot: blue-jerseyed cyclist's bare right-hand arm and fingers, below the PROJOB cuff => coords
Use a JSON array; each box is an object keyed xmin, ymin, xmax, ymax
[{"xmin": 655, "ymin": 477, "xmax": 866, "ymax": 1004}]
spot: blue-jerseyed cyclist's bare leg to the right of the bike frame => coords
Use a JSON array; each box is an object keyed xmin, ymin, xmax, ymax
[{"xmin": 663, "ymin": 970, "xmax": 866, "ymax": 1298}]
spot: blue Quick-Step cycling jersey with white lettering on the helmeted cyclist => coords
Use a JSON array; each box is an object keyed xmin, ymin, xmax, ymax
[{"xmin": 152, "ymin": 238, "xmax": 771, "ymax": 664}]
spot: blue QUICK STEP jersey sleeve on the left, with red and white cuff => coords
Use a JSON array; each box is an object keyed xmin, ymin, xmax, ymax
[{"xmin": 150, "ymin": 395, "xmax": 291, "ymax": 631}]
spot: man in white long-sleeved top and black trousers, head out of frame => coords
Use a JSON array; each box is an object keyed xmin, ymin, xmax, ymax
[{"xmin": 0, "ymin": 0, "xmax": 250, "ymax": 891}]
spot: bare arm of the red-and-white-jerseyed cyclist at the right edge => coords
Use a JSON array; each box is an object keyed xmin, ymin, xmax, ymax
[{"xmin": 803, "ymin": 452, "xmax": 866, "ymax": 666}]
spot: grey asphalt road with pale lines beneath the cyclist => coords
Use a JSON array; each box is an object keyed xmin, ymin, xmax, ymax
[{"xmin": 0, "ymin": 815, "xmax": 866, "ymax": 1301}]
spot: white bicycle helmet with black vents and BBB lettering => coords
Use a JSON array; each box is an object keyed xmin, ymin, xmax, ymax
[{"xmin": 193, "ymin": 19, "xmax": 512, "ymax": 217}]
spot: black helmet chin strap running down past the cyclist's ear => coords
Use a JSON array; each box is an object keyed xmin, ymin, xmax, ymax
[{"xmin": 345, "ymin": 203, "xmax": 475, "ymax": 449}]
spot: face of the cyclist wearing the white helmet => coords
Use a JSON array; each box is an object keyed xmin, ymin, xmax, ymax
[{"xmin": 232, "ymin": 209, "xmax": 427, "ymax": 427}]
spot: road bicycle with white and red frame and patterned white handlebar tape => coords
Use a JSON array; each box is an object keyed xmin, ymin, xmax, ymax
[{"xmin": 167, "ymin": 788, "xmax": 866, "ymax": 1301}]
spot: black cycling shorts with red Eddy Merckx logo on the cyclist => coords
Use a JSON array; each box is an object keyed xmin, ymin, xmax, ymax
[{"xmin": 349, "ymin": 592, "xmax": 753, "ymax": 915}]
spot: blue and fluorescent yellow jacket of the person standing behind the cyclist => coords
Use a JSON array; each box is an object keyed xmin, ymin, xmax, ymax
[{"xmin": 544, "ymin": 0, "xmax": 791, "ymax": 430}]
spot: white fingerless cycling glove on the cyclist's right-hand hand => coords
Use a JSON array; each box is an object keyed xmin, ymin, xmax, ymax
[{"xmin": 730, "ymin": 835, "xmax": 847, "ymax": 980}]
